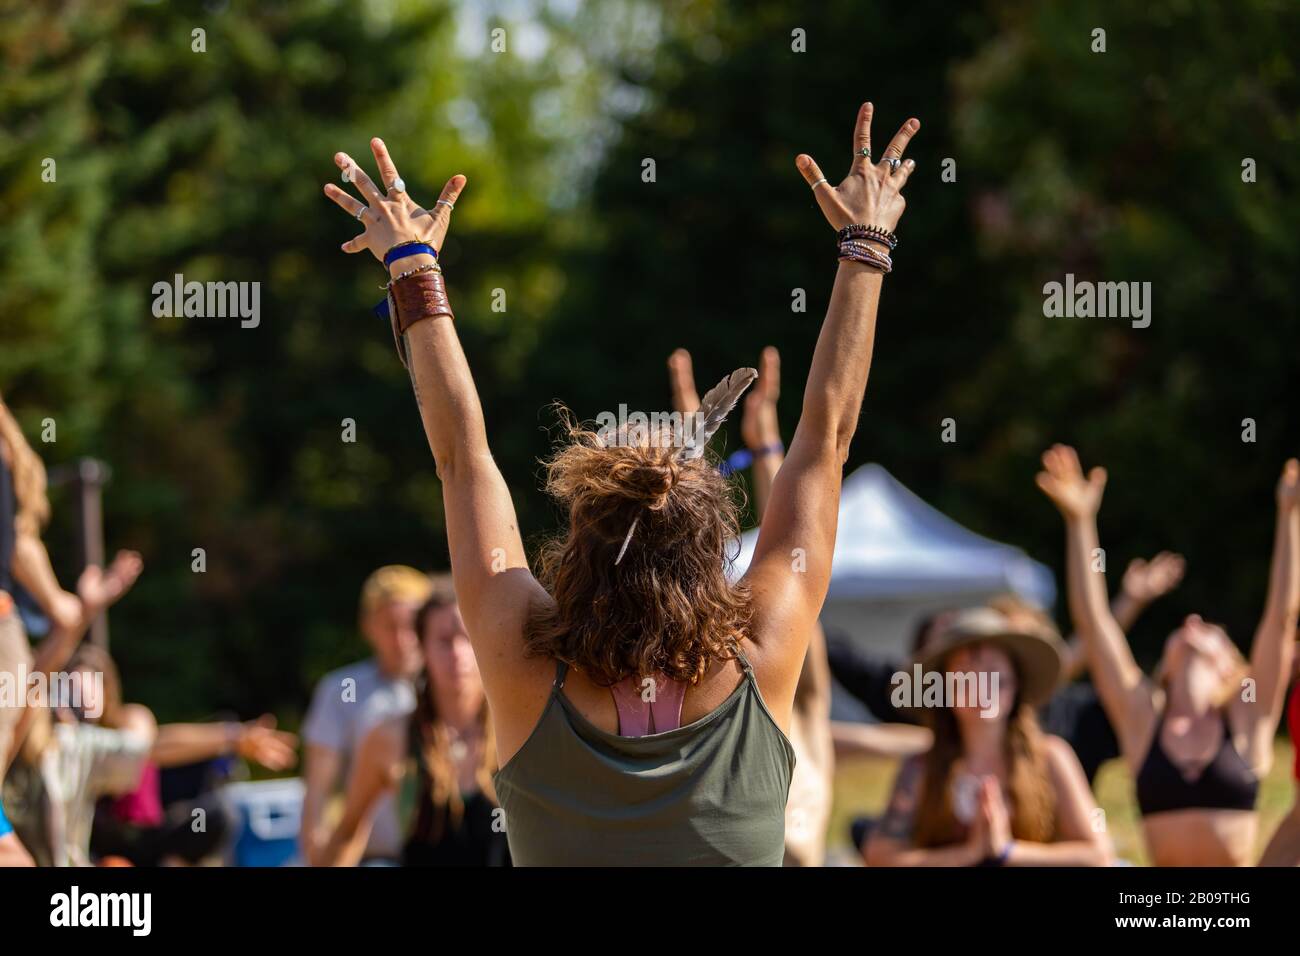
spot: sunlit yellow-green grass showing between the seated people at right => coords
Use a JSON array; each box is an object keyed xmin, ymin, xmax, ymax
[{"xmin": 828, "ymin": 740, "xmax": 1295, "ymax": 866}]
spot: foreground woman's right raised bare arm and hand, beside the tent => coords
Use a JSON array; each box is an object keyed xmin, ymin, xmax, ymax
[{"xmin": 746, "ymin": 104, "xmax": 920, "ymax": 706}]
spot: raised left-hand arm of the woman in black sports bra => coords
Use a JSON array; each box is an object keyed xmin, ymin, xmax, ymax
[{"xmin": 1037, "ymin": 445, "xmax": 1156, "ymax": 763}]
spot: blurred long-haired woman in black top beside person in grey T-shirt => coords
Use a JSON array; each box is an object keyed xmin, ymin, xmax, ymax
[{"xmin": 316, "ymin": 575, "xmax": 510, "ymax": 866}]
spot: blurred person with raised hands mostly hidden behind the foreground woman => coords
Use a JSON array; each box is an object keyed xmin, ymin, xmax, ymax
[{"xmin": 668, "ymin": 346, "xmax": 835, "ymax": 866}]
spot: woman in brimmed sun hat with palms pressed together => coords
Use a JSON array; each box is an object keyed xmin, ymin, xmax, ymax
[{"xmin": 866, "ymin": 607, "xmax": 1112, "ymax": 866}]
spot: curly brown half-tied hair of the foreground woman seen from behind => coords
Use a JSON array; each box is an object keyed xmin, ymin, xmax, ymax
[{"xmin": 524, "ymin": 423, "xmax": 751, "ymax": 685}]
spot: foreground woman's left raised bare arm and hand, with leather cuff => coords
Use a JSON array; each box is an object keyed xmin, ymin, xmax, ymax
[{"xmin": 325, "ymin": 139, "xmax": 549, "ymax": 718}]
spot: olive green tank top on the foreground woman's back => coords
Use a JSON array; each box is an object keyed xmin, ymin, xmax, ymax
[{"xmin": 495, "ymin": 654, "xmax": 794, "ymax": 866}]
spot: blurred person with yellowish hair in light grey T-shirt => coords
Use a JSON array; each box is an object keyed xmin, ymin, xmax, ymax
[{"xmin": 300, "ymin": 564, "xmax": 432, "ymax": 865}]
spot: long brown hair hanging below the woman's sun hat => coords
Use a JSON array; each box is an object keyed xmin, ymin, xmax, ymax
[{"xmin": 915, "ymin": 660, "xmax": 1056, "ymax": 847}]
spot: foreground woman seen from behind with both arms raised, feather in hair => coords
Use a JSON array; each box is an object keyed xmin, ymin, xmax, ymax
[{"xmin": 325, "ymin": 103, "xmax": 920, "ymax": 866}]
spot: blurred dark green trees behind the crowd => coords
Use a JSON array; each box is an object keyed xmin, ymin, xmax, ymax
[{"xmin": 0, "ymin": 0, "xmax": 1300, "ymax": 780}]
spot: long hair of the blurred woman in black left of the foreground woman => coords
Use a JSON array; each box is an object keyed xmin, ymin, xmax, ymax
[{"xmin": 413, "ymin": 575, "xmax": 497, "ymax": 843}]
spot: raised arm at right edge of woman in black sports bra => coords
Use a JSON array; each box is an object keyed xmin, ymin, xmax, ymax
[{"xmin": 1251, "ymin": 459, "xmax": 1300, "ymax": 765}]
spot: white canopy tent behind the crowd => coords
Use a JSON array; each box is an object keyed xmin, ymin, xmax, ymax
[{"xmin": 731, "ymin": 464, "xmax": 1056, "ymax": 676}]
